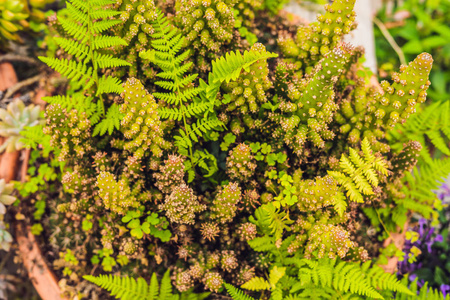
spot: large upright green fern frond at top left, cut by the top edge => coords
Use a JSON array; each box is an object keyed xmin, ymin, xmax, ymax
[{"xmin": 39, "ymin": 0, "xmax": 130, "ymax": 135}]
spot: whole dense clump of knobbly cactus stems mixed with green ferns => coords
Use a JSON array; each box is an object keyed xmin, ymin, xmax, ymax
[{"xmin": 20, "ymin": 0, "xmax": 450, "ymax": 300}]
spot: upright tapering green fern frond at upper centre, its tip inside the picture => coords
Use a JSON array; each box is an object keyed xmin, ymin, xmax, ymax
[{"xmin": 139, "ymin": 9, "xmax": 222, "ymax": 160}]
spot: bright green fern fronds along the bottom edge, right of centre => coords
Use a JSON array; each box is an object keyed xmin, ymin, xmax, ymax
[{"xmin": 229, "ymin": 258, "xmax": 418, "ymax": 299}]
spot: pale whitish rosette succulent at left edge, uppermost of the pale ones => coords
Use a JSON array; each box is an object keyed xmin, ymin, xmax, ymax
[{"xmin": 0, "ymin": 99, "xmax": 43, "ymax": 152}]
